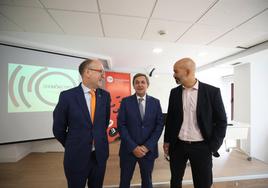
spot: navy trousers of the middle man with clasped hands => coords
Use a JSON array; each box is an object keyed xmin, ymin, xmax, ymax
[{"xmin": 119, "ymin": 157, "xmax": 155, "ymax": 188}]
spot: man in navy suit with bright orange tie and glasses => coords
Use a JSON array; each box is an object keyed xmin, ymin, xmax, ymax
[{"xmin": 53, "ymin": 60, "xmax": 111, "ymax": 188}]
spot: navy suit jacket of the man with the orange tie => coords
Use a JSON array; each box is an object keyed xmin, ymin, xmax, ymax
[{"xmin": 53, "ymin": 84, "xmax": 111, "ymax": 173}]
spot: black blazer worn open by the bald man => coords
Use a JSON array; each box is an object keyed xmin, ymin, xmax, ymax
[{"xmin": 164, "ymin": 82, "xmax": 227, "ymax": 153}]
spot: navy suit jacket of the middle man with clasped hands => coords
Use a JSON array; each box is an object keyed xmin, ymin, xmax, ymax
[{"xmin": 117, "ymin": 94, "xmax": 163, "ymax": 159}]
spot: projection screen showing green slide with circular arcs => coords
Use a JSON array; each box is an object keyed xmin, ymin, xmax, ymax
[{"xmin": 0, "ymin": 44, "xmax": 87, "ymax": 144}]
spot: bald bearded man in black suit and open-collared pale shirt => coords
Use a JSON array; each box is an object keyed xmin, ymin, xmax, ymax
[{"xmin": 163, "ymin": 58, "xmax": 227, "ymax": 188}]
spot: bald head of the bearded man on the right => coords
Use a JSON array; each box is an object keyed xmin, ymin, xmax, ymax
[{"xmin": 173, "ymin": 58, "xmax": 196, "ymax": 87}]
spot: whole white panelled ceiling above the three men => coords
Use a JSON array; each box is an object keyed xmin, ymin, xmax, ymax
[{"xmin": 0, "ymin": 0, "xmax": 268, "ymax": 73}]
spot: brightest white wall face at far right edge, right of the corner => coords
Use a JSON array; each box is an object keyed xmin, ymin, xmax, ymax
[{"xmin": 250, "ymin": 59, "xmax": 268, "ymax": 163}]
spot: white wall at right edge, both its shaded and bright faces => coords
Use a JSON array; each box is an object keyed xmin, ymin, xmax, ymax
[{"xmin": 234, "ymin": 58, "xmax": 268, "ymax": 163}]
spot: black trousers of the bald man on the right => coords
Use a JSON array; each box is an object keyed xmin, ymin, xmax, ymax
[{"xmin": 170, "ymin": 140, "xmax": 213, "ymax": 188}]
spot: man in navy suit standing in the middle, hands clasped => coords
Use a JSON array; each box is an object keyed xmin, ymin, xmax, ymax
[{"xmin": 118, "ymin": 73, "xmax": 163, "ymax": 188}]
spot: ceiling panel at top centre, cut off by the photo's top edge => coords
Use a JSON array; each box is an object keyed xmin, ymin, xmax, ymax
[{"xmin": 99, "ymin": 0, "xmax": 155, "ymax": 17}]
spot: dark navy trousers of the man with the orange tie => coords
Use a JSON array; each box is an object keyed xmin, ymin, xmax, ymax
[{"xmin": 65, "ymin": 151, "xmax": 106, "ymax": 188}]
